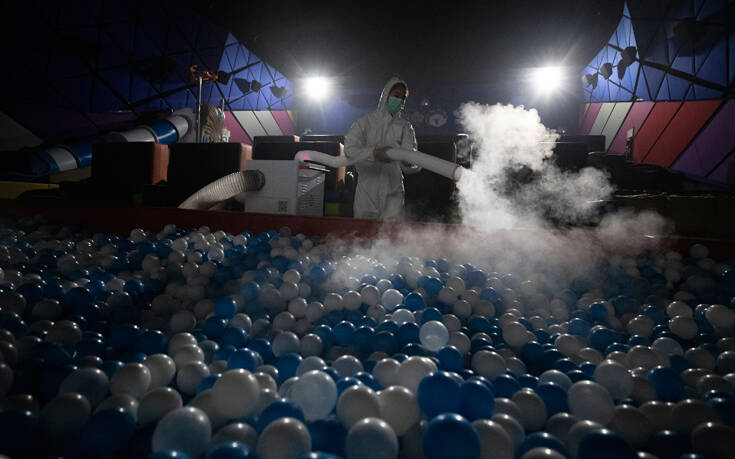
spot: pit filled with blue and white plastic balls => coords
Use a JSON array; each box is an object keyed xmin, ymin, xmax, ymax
[{"xmin": 0, "ymin": 218, "xmax": 735, "ymax": 459}]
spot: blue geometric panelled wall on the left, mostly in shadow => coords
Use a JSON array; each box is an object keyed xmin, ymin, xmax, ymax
[{"xmin": 0, "ymin": 0, "xmax": 294, "ymax": 154}]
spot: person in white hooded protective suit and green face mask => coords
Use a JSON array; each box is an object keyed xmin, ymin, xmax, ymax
[{"xmin": 345, "ymin": 77, "xmax": 421, "ymax": 219}]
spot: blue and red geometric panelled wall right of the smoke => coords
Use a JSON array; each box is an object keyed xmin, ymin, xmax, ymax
[{"xmin": 580, "ymin": 0, "xmax": 735, "ymax": 184}]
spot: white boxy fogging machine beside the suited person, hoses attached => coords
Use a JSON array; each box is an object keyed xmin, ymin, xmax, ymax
[{"xmin": 245, "ymin": 159, "xmax": 327, "ymax": 217}]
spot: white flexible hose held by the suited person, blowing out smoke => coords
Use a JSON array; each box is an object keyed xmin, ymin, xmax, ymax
[{"xmin": 294, "ymin": 148, "xmax": 463, "ymax": 181}]
